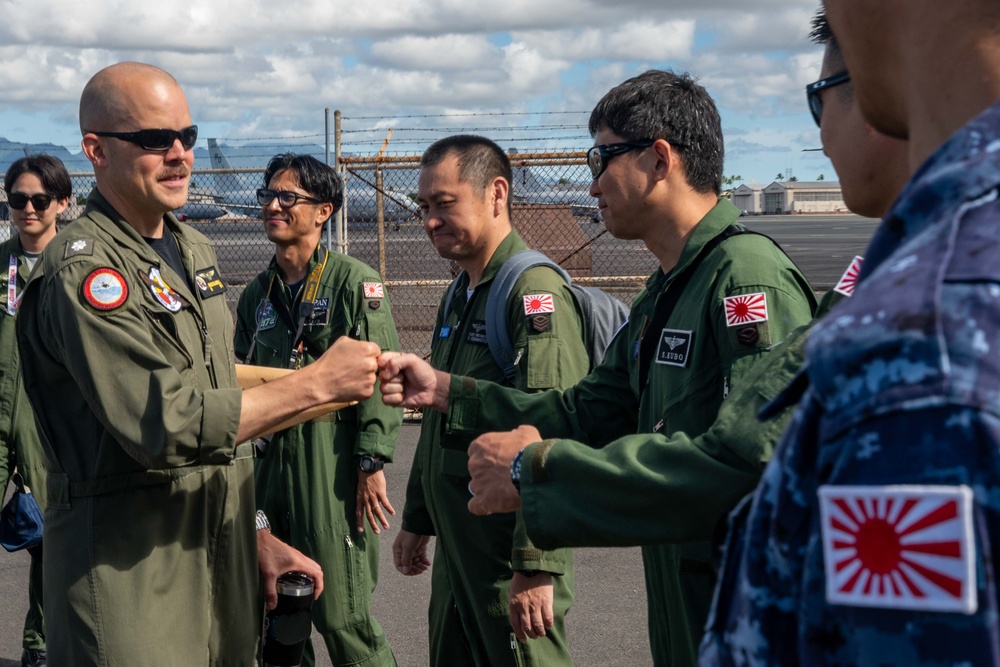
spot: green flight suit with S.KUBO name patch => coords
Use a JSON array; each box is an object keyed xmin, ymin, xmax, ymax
[{"xmin": 445, "ymin": 200, "xmax": 816, "ymax": 666}]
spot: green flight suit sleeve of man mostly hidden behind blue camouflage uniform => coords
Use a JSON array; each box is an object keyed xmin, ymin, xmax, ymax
[{"xmin": 521, "ymin": 290, "xmax": 844, "ymax": 547}]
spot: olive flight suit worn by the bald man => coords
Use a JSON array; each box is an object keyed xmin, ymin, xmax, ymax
[{"xmin": 17, "ymin": 190, "xmax": 259, "ymax": 667}]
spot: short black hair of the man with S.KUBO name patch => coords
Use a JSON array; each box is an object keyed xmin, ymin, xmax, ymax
[{"xmin": 589, "ymin": 69, "xmax": 725, "ymax": 194}]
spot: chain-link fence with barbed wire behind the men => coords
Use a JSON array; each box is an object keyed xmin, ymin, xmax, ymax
[{"xmin": 0, "ymin": 123, "xmax": 656, "ymax": 355}]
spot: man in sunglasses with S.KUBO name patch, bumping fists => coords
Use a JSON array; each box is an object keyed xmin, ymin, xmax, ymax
[{"xmin": 380, "ymin": 70, "xmax": 816, "ymax": 666}]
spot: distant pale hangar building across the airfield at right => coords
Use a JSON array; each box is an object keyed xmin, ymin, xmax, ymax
[{"xmin": 729, "ymin": 181, "xmax": 850, "ymax": 215}]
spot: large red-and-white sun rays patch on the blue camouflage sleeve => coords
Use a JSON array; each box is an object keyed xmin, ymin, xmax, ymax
[{"xmin": 819, "ymin": 486, "xmax": 977, "ymax": 614}]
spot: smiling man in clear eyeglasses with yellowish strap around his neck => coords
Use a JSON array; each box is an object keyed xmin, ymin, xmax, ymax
[{"xmin": 235, "ymin": 153, "xmax": 403, "ymax": 667}]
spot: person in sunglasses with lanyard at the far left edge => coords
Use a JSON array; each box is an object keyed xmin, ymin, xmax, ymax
[{"xmin": 0, "ymin": 155, "xmax": 73, "ymax": 667}]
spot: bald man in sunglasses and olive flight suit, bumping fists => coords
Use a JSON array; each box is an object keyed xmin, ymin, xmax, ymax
[{"xmin": 17, "ymin": 63, "xmax": 379, "ymax": 666}]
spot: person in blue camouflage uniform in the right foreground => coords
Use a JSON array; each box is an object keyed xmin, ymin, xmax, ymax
[{"xmin": 701, "ymin": 0, "xmax": 1000, "ymax": 665}]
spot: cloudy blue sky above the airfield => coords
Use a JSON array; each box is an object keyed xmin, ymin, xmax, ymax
[{"xmin": 0, "ymin": 0, "xmax": 835, "ymax": 185}]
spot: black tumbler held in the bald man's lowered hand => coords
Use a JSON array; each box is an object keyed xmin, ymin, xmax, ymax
[{"xmin": 264, "ymin": 572, "xmax": 314, "ymax": 667}]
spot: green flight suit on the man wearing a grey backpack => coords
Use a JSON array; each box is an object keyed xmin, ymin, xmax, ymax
[{"xmin": 403, "ymin": 232, "xmax": 590, "ymax": 667}]
